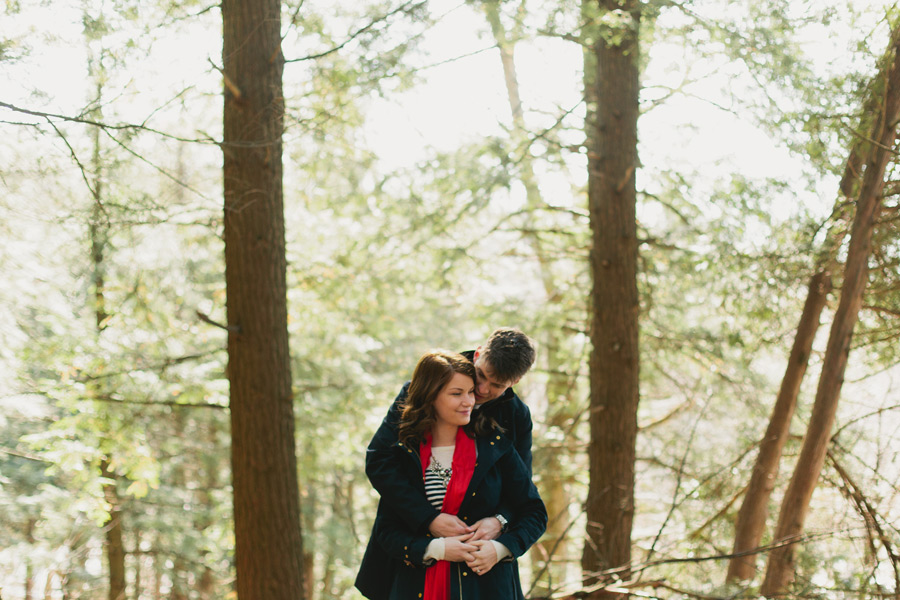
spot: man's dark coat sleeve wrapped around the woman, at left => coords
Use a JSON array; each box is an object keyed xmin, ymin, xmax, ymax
[{"xmin": 366, "ymin": 384, "xmax": 440, "ymax": 534}]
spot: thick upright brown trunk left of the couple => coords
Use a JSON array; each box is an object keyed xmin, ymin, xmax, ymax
[{"xmin": 222, "ymin": 0, "xmax": 305, "ymax": 600}]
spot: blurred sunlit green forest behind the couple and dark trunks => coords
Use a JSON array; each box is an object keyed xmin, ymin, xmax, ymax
[{"xmin": 0, "ymin": 0, "xmax": 900, "ymax": 600}]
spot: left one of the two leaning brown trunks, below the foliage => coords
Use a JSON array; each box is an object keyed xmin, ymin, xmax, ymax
[{"xmin": 727, "ymin": 271, "xmax": 831, "ymax": 581}]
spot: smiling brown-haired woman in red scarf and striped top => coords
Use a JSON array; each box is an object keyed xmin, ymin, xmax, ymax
[{"xmin": 356, "ymin": 351, "xmax": 547, "ymax": 600}]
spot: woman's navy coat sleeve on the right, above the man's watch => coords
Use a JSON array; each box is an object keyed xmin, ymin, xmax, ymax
[{"xmin": 497, "ymin": 452, "xmax": 547, "ymax": 557}]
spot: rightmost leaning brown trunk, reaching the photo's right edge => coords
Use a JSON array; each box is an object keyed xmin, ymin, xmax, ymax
[{"xmin": 761, "ymin": 27, "xmax": 900, "ymax": 597}]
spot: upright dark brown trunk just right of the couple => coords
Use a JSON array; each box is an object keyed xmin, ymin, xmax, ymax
[{"xmin": 581, "ymin": 0, "xmax": 641, "ymax": 583}]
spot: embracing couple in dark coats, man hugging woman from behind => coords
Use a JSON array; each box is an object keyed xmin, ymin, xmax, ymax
[{"xmin": 356, "ymin": 328, "xmax": 547, "ymax": 600}]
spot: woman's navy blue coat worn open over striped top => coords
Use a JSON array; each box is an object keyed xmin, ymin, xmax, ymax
[{"xmin": 356, "ymin": 431, "xmax": 547, "ymax": 600}]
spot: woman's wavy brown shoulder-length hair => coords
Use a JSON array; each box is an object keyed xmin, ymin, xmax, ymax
[{"xmin": 397, "ymin": 350, "xmax": 481, "ymax": 445}]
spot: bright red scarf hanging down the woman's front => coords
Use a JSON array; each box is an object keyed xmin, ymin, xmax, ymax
[{"xmin": 419, "ymin": 427, "xmax": 475, "ymax": 600}]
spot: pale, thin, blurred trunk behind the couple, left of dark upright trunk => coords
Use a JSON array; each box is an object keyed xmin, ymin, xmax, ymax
[{"xmin": 483, "ymin": 0, "xmax": 575, "ymax": 597}]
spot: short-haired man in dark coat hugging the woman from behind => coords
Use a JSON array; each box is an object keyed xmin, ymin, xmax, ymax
[{"xmin": 366, "ymin": 328, "xmax": 535, "ymax": 541}]
